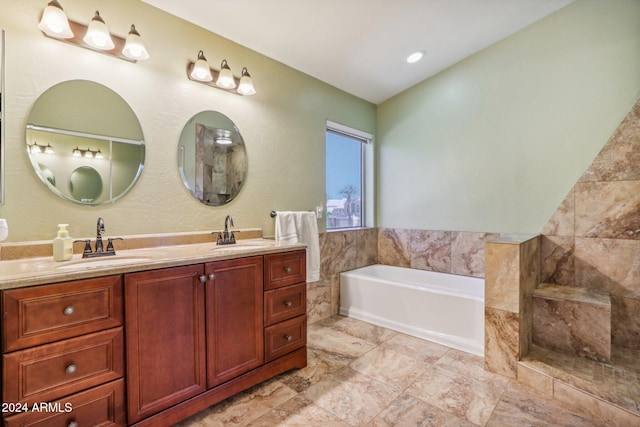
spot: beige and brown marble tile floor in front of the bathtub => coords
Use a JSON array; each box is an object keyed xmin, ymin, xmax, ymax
[{"xmin": 178, "ymin": 316, "xmax": 625, "ymax": 427}]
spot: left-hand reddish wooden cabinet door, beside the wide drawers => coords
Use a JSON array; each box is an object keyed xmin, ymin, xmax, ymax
[{"xmin": 125, "ymin": 265, "xmax": 206, "ymax": 423}]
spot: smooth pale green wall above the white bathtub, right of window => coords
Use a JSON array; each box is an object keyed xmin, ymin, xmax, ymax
[{"xmin": 377, "ymin": 0, "xmax": 640, "ymax": 233}]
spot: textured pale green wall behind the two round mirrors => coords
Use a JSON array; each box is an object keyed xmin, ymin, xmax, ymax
[{"xmin": 0, "ymin": 0, "xmax": 376, "ymax": 241}]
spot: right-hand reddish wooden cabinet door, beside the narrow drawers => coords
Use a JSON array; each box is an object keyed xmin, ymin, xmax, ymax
[{"xmin": 206, "ymin": 257, "xmax": 264, "ymax": 388}]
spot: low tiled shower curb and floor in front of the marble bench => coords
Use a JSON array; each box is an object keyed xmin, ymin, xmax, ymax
[{"xmin": 518, "ymin": 345, "xmax": 640, "ymax": 425}]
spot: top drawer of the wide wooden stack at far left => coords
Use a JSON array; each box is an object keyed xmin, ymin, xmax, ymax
[{"xmin": 3, "ymin": 275, "xmax": 122, "ymax": 352}]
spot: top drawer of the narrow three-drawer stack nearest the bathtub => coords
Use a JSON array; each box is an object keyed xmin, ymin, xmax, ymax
[{"xmin": 264, "ymin": 250, "xmax": 307, "ymax": 289}]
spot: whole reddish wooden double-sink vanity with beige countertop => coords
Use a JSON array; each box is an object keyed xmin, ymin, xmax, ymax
[{"xmin": 0, "ymin": 239, "xmax": 307, "ymax": 427}]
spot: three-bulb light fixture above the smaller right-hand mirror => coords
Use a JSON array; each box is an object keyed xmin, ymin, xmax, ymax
[{"xmin": 187, "ymin": 51, "xmax": 256, "ymax": 95}]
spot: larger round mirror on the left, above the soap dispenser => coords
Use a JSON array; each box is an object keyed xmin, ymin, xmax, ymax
[{"xmin": 26, "ymin": 80, "xmax": 145, "ymax": 205}]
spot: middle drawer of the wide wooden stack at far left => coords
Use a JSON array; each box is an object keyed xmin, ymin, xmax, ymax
[{"xmin": 3, "ymin": 327, "xmax": 124, "ymax": 403}]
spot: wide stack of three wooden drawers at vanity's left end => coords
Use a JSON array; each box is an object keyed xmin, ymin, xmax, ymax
[{"xmin": 1, "ymin": 275, "xmax": 126, "ymax": 427}]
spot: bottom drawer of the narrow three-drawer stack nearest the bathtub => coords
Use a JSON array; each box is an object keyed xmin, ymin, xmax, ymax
[{"xmin": 264, "ymin": 315, "xmax": 307, "ymax": 362}]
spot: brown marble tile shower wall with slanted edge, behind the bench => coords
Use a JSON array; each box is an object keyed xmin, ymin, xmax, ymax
[{"xmin": 541, "ymin": 101, "xmax": 640, "ymax": 349}]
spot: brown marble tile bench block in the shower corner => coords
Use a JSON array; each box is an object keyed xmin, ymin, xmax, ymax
[{"xmin": 532, "ymin": 283, "xmax": 611, "ymax": 362}]
